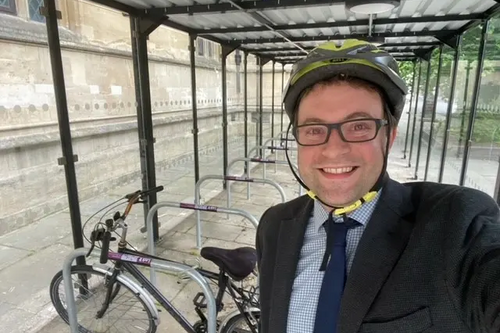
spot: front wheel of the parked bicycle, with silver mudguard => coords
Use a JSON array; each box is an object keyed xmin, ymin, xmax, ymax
[{"xmin": 50, "ymin": 265, "xmax": 156, "ymax": 333}]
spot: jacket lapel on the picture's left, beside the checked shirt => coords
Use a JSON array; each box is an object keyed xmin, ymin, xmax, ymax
[{"xmin": 269, "ymin": 197, "xmax": 314, "ymax": 333}]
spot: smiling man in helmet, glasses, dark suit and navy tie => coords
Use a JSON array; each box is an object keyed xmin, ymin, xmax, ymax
[{"xmin": 256, "ymin": 40, "xmax": 500, "ymax": 333}]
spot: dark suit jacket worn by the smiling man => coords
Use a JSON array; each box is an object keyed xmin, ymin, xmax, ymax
[{"xmin": 256, "ymin": 180, "xmax": 500, "ymax": 333}]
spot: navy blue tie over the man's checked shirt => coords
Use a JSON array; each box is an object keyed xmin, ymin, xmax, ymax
[{"xmin": 314, "ymin": 213, "xmax": 357, "ymax": 333}]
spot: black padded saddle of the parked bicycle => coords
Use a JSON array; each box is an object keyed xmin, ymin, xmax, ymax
[{"xmin": 200, "ymin": 246, "xmax": 257, "ymax": 281}]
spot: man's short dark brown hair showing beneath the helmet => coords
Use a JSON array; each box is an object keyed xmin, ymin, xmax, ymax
[{"xmin": 293, "ymin": 74, "xmax": 398, "ymax": 129}]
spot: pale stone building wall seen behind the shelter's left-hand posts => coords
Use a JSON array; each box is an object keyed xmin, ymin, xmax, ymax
[{"xmin": 0, "ymin": 0, "xmax": 288, "ymax": 235}]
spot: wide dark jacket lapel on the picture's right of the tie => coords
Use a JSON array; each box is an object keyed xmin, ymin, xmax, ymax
[{"xmin": 339, "ymin": 180, "xmax": 413, "ymax": 332}]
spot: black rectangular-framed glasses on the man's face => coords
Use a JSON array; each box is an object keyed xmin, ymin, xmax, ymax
[{"xmin": 294, "ymin": 118, "xmax": 389, "ymax": 146}]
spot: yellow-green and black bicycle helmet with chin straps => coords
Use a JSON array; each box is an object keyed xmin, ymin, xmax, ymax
[{"xmin": 283, "ymin": 39, "xmax": 408, "ymax": 217}]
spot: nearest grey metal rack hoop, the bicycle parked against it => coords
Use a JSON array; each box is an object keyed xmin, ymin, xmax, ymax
[{"xmin": 63, "ymin": 248, "xmax": 217, "ymax": 333}]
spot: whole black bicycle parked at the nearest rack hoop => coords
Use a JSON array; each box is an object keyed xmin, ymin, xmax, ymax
[{"xmin": 50, "ymin": 186, "xmax": 260, "ymax": 333}]
